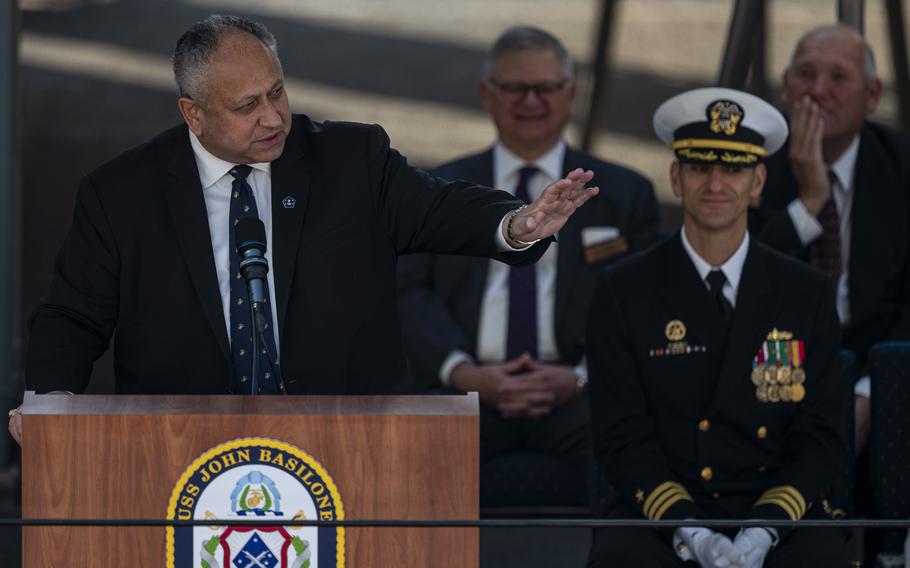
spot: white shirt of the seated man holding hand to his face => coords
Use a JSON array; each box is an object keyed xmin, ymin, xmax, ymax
[{"xmin": 787, "ymin": 135, "xmax": 872, "ymax": 398}]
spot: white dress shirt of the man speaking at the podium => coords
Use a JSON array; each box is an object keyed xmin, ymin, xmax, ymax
[{"xmin": 190, "ymin": 131, "xmax": 281, "ymax": 356}]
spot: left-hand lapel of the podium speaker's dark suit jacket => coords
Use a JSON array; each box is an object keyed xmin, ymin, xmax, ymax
[{"xmin": 167, "ymin": 130, "xmax": 231, "ymax": 361}]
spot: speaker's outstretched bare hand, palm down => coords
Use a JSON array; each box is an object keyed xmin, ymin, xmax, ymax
[{"xmin": 502, "ymin": 168, "xmax": 600, "ymax": 248}]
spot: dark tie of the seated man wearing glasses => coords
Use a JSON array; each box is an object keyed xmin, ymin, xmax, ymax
[{"xmin": 506, "ymin": 166, "xmax": 538, "ymax": 360}]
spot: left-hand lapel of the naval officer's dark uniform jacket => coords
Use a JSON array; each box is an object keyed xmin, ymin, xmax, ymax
[{"xmin": 661, "ymin": 233, "xmax": 724, "ymax": 365}]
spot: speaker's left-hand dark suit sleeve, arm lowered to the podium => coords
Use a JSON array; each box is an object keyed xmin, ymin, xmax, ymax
[{"xmin": 26, "ymin": 177, "xmax": 120, "ymax": 392}]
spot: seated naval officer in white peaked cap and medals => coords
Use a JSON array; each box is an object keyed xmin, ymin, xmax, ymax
[{"xmin": 588, "ymin": 88, "xmax": 846, "ymax": 568}]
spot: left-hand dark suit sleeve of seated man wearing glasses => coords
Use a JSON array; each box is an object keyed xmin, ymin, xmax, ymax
[{"xmin": 398, "ymin": 254, "xmax": 469, "ymax": 387}]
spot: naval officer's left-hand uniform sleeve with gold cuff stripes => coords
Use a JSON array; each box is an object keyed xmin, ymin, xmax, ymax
[{"xmin": 587, "ymin": 272, "xmax": 702, "ymax": 520}]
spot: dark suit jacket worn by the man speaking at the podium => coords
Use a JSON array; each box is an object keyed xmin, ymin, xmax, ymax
[{"xmin": 26, "ymin": 116, "xmax": 546, "ymax": 394}]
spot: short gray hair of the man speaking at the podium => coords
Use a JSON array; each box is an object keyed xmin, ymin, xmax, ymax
[{"xmin": 171, "ymin": 14, "xmax": 278, "ymax": 101}]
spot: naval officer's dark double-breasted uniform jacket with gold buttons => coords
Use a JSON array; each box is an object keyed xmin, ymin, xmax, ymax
[{"xmin": 588, "ymin": 236, "xmax": 847, "ymax": 519}]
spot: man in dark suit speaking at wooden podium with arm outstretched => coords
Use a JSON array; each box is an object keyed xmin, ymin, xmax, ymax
[{"xmin": 13, "ymin": 16, "xmax": 597, "ymax": 444}]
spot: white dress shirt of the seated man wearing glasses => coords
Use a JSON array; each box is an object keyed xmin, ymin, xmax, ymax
[{"xmin": 439, "ymin": 141, "xmax": 566, "ymax": 385}]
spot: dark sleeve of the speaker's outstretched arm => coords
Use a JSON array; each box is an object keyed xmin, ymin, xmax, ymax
[{"xmin": 369, "ymin": 126, "xmax": 550, "ymax": 264}]
